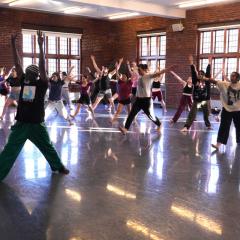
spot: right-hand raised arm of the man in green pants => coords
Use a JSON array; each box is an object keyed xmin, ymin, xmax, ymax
[{"xmin": 37, "ymin": 30, "xmax": 48, "ymax": 81}]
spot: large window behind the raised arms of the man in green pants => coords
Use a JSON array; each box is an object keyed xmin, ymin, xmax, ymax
[{"xmin": 22, "ymin": 30, "xmax": 81, "ymax": 76}]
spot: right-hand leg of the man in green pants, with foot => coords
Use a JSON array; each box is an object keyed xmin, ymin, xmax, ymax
[{"xmin": 29, "ymin": 123, "xmax": 67, "ymax": 174}]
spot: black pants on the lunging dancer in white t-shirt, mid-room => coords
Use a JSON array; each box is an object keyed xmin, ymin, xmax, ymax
[{"xmin": 125, "ymin": 98, "xmax": 161, "ymax": 129}]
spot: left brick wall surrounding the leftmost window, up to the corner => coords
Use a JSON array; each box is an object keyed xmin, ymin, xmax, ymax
[{"xmin": 0, "ymin": 8, "xmax": 115, "ymax": 74}]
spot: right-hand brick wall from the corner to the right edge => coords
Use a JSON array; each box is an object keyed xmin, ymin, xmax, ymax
[{"xmin": 115, "ymin": 3, "xmax": 240, "ymax": 107}]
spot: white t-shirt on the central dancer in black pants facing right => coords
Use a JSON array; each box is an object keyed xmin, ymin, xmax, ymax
[{"xmin": 136, "ymin": 74, "xmax": 153, "ymax": 98}]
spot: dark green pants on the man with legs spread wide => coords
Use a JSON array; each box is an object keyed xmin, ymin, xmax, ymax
[{"xmin": 0, "ymin": 122, "xmax": 63, "ymax": 181}]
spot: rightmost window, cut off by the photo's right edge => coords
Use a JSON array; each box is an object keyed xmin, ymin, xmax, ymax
[{"xmin": 199, "ymin": 26, "xmax": 240, "ymax": 80}]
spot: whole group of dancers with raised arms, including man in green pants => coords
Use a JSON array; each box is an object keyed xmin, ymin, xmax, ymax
[{"xmin": 0, "ymin": 31, "xmax": 240, "ymax": 180}]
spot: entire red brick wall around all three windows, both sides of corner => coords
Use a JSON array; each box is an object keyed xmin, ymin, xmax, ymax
[{"xmin": 0, "ymin": 3, "xmax": 240, "ymax": 107}]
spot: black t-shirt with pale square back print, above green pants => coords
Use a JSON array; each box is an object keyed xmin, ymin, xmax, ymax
[{"xmin": 15, "ymin": 74, "xmax": 48, "ymax": 123}]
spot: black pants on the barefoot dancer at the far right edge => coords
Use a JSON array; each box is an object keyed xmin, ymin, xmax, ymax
[{"xmin": 217, "ymin": 108, "xmax": 240, "ymax": 145}]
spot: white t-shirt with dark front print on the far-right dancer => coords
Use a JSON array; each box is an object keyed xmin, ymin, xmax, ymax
[{"xmin": 217, "ymin": 81, "xmax": 240, "ymax": 112}]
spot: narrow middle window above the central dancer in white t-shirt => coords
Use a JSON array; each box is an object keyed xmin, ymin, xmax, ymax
[{"xmin": 138, "ymin": 33, "xmax": 166, "ymax": 75}]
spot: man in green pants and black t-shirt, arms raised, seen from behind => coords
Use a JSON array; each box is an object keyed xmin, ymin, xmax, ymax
[{"xmin": 0, "ymin": 31, "xmax": 69, "ymax": 181}]
